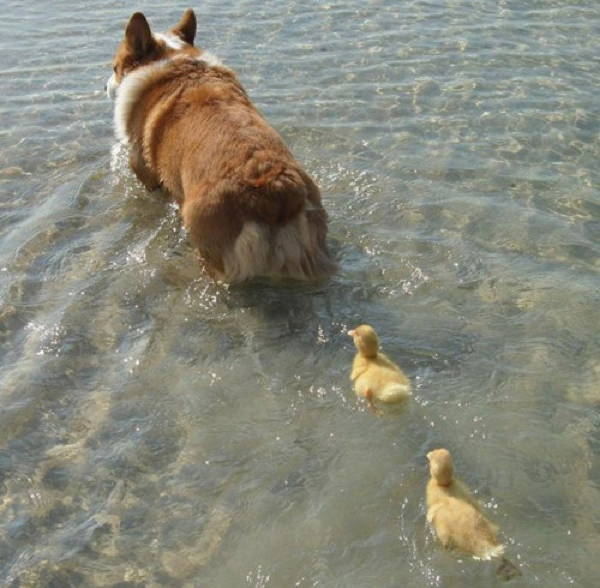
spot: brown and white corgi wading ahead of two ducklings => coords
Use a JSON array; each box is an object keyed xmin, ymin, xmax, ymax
[{"xmin": 106, "ymin": 9, "xmax": 335, "ymax": 283}]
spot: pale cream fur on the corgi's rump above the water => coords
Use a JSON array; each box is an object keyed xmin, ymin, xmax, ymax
[{"xmin": 218, "ymin": 210, "xmax": 334, "ymax": 283}]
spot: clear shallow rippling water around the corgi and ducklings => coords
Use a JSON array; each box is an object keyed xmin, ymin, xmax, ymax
[{"xmin": 0, "ymin": 0, "xmax": 600, "ymax": 588}]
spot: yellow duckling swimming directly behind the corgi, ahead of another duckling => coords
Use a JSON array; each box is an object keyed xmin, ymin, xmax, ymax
[{"xmin": 348, "ymin": 325, "xmax": 411, "ymax": 412}]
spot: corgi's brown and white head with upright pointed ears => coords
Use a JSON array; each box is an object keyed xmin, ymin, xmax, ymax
[{"xmin": 106, "ymin": 8, "xmax": 199, "ymax": 98}]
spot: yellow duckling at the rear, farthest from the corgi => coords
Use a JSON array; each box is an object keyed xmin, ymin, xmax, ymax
[{"xmin": 427, "ymin": 449, "xmax": 521, "ymax": 580}]
